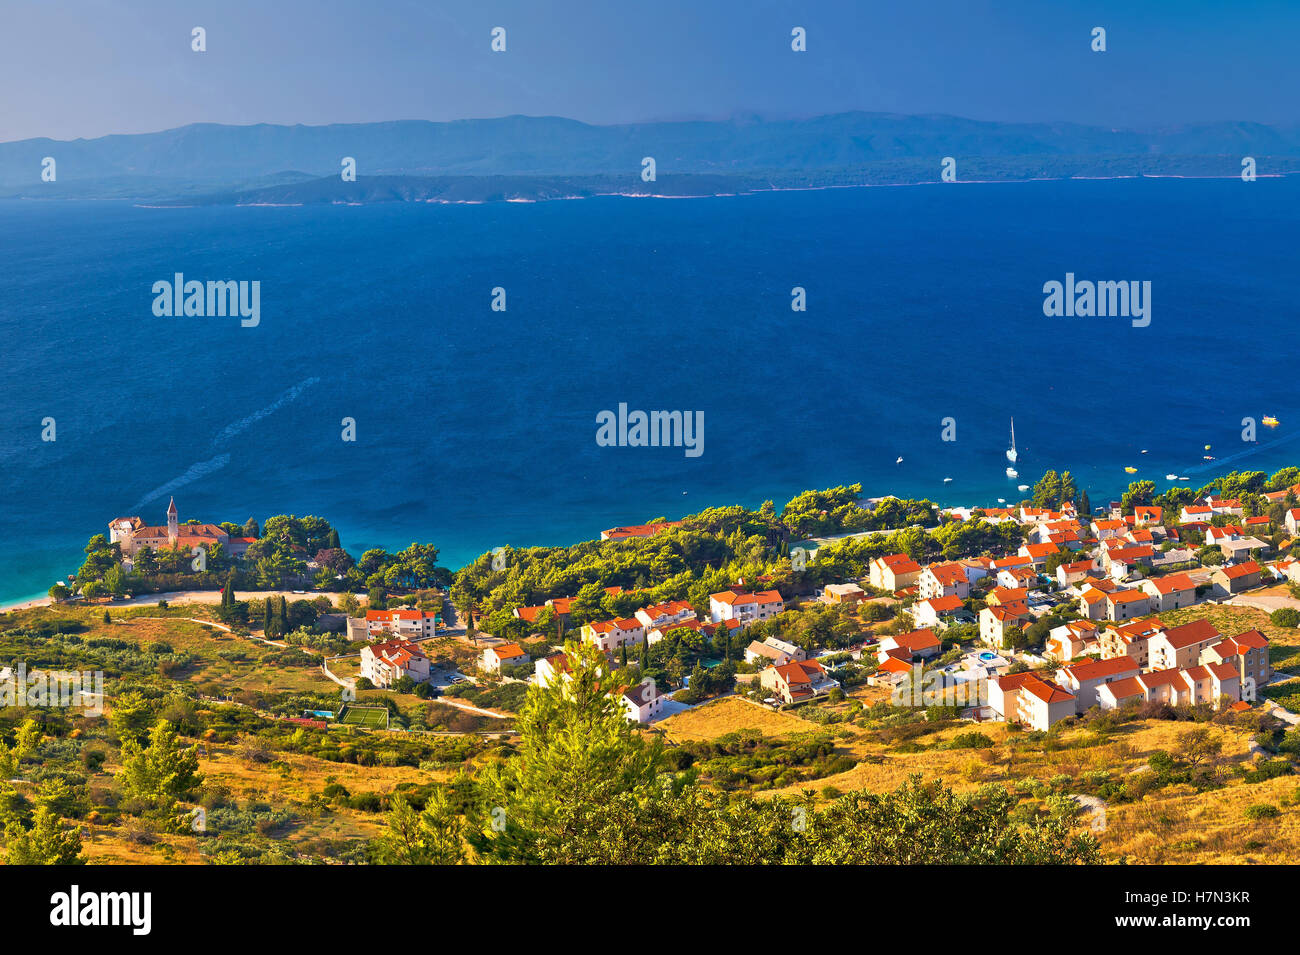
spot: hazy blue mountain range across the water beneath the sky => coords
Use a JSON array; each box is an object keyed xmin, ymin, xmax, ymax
[{"xmin": 0, "ymin": 112, "xmax": 1300, "ymax": 203}]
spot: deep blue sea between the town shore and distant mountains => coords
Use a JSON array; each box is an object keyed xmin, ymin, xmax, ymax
[{"xmin": 0, "ymin": 179, "xmax": 1300, "ymax": 600}]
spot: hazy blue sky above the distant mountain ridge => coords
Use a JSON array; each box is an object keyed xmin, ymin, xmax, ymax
[{"xmin": 0, "ymin": 0, "xmax": 1300, "ymax": 140}]
